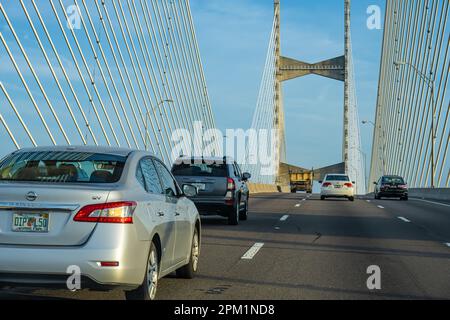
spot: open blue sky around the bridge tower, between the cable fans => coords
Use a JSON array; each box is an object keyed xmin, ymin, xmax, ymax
[{"xmin": 191, "ymin": 0, "xmax": 385, "ymax": 167}]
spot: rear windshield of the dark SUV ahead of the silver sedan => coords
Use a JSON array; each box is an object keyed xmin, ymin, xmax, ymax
[{"xmin": 172, "ymin": 163, "xmax": 228, "ymax": 177}]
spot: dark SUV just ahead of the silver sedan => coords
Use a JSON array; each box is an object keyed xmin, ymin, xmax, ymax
[{"xmin": 172, "ymin": 157, "xmax": 251, "ymax": 225}]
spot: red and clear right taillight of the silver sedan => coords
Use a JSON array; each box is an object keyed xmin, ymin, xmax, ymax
[{"xmin": 73, "ymin": 201, "xmax": 137, "ymax": 224}]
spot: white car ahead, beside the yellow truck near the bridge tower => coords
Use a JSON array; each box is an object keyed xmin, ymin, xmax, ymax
[{"xmin": 320, "ymin": 174, "xmax": 355, "ymax": 201}]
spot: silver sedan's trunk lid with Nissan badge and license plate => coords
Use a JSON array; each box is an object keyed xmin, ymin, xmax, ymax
[{"xmin": 0, "ymin": 183, "xmax": 109, "ymax": 246}]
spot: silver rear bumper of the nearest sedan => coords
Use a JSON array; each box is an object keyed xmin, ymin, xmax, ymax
[{"xmin": 0, "ymin": 225, "xmax": 150, "ymax": 289}]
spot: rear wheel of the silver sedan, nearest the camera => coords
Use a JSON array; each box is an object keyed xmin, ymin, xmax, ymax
[{"xmin": 125, "ymin": 242, "xmax": 159, "ymax": 300}]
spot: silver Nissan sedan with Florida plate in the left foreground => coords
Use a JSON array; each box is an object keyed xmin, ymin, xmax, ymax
[{"xmin": 0, "ymin": 147, "xmax": 201, "ymax": 300}]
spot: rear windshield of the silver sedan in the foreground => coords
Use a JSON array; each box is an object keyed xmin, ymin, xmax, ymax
[{"xmin": 0, "ymin": 151, "xmax": 127, "ymax": 183}]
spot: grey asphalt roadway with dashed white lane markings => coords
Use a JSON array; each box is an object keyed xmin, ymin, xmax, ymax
[{"xmin": 0, "ymin": 194, "xmax": 450, "ymax": 300}]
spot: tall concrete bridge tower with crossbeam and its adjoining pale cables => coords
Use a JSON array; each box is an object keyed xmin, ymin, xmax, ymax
[{"xmin": 251, "ymin": 0, "xmax": 366, "ymax": 194}]
